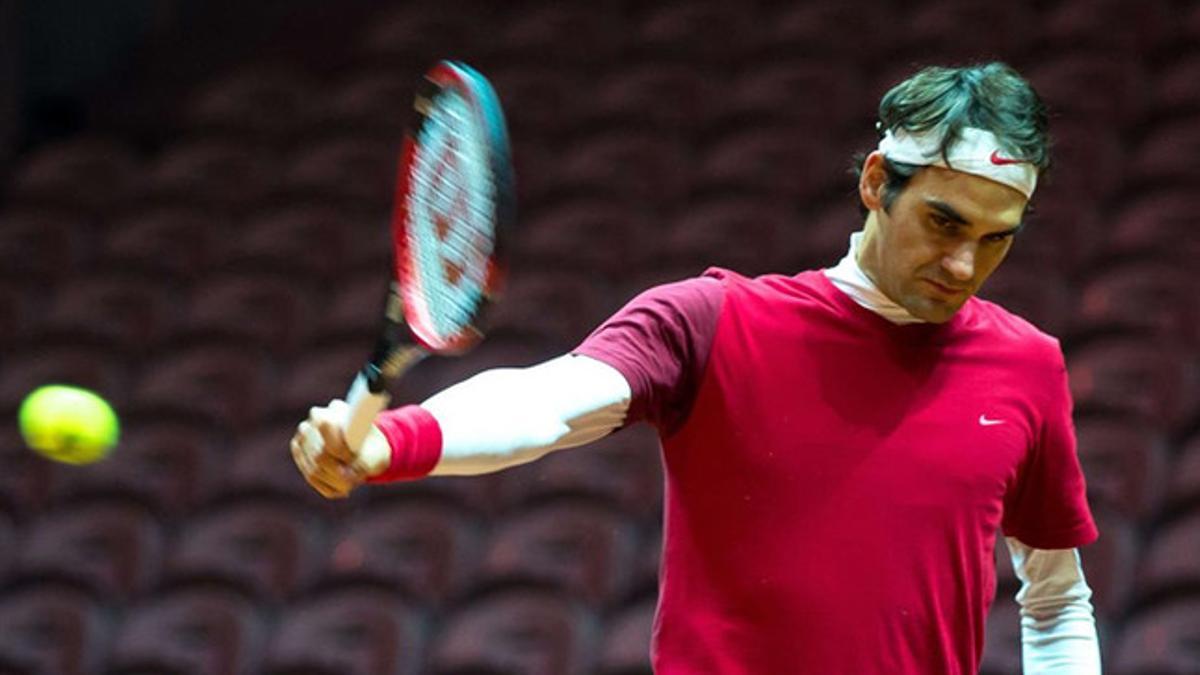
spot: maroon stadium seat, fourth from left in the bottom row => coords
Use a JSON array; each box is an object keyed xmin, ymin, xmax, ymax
[{"xmin": 428, "ymin": 590, "xmax": 600, "ymax": 675}]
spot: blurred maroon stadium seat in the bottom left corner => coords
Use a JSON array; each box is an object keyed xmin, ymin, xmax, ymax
[{"xmin": 0, "ymin": 584, "xmax": 113, "ymax": 675}]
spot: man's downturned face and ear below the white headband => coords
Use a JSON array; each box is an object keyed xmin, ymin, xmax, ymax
[{"xmin": 858, "ymin": 153, "xmax": 1027, "ymax": 323}]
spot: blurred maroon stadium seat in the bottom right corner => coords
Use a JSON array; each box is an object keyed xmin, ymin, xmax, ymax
[{"xmin": 1105, "ymin": 595, "xmax": 1200, "ymax": 675}]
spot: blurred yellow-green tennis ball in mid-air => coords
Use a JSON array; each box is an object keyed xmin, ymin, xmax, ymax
[{"xmin": 17, "ymin": 384, "xmax": 121, "ymax": 464}]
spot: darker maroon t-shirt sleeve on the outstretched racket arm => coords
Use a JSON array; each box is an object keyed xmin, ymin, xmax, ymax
[{"xmin": 571, "ymin": 271, "xmax": 725, "ymax": 434}]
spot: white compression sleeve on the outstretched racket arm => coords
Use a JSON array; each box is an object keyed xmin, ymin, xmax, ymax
[{"xmin": 421, "ymin": 354, "xmax": 632, "ymax": 476}]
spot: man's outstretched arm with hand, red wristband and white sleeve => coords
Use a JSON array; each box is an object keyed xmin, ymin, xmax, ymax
[{"xmin": 292, "ymin": 354, "xmax": 631, "ymax": 497}]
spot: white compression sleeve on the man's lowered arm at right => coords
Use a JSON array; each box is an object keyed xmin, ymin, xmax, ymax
[{"xmin": 1004, "ymin": 537, "xmax": 1100, "ymax": 675}]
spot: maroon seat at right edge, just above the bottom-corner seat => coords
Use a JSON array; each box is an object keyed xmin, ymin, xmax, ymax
[{"xmin": 1135, "ymin": 509, "xmax": 1200, "ymax": 597}]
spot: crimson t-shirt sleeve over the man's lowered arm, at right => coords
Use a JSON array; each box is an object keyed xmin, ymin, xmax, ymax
[{"xmin": 1002, "ymin": 345, "xmax": 1098, "ymax": 549}]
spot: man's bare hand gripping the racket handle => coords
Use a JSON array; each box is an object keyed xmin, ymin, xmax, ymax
[{"xmin": 290, "ymin": 400, "xmax": 388, "ymax": 500}]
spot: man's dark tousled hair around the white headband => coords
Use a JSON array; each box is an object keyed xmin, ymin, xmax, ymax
[{"xmin": 854, "ymin": 61, "xmax": 1050, "ymax": 211}]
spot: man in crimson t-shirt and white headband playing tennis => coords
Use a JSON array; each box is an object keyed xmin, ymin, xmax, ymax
[{"xmin": 292, "ymin": 64, "xmax": 1099, "ymax": 675}]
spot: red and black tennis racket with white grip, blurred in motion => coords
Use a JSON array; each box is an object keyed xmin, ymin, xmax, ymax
[{"xmin": 344, "ymin": 61, "xmax": 516, "ymax": 450}]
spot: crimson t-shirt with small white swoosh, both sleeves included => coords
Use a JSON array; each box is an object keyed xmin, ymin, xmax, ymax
[{"xmin": 575, "ymin": 270, "xmax": 1097, "ymax": 675}]
